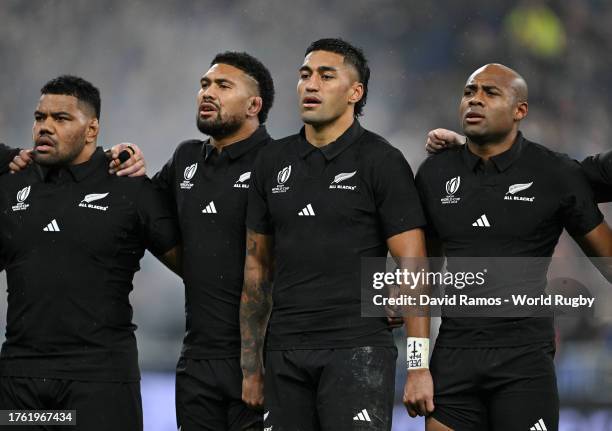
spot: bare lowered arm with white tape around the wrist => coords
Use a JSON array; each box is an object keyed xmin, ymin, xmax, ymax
[{"xmin": 387, "ymin": 229, "xmax": 434, "ymax": 417}]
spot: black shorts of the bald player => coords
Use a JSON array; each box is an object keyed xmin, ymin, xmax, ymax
[{"xmin": 430, "ymin": 343, "xmax": 559, "ymax": 431}]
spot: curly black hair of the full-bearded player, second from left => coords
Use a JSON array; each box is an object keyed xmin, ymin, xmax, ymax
[{"xmin": 210, "ymin": 51, "xmax": 274, "ymax": 124}]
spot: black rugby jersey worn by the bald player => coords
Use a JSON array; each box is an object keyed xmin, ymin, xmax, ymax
[{"xmin": 416, "ymin": 133, "xmax": 603, "ymax": 347}]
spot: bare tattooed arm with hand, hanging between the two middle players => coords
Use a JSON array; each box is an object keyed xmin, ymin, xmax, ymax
[{"xmin": 240, "ymin": 229, "xmax": 274, "ymax": 408}]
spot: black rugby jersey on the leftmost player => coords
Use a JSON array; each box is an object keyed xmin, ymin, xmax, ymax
[{"xmin": 0, "ymin": 148, "xmax": 179, "ymax": 381}]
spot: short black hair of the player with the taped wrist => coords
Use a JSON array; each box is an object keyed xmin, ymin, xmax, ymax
[{"xmin": 304, "ymin": 38, "xmax": 370, "ymax": 117}]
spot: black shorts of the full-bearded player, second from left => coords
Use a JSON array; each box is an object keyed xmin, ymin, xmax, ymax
[{"xmin": 176, "ymin": 358, "xmax": 263, "ymax": 431}]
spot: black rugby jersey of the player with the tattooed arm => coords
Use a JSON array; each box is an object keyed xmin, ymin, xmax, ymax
[{"xmin": 247, "ymin": 121, "xmax": 425, "ymax": 349}]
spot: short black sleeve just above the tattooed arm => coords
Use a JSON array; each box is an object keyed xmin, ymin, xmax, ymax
[{"xmin": 246, "ymin": 153, "xmax": 274, "ymax": 235}]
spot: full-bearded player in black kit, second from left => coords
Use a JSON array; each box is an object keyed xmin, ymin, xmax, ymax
[{"xmin": 153, "ymin": 52, "xmax": 274, "ymax": 431}]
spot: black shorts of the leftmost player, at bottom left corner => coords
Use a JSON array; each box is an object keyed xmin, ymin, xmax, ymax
[{"xmin": 0, "ymin": 376, "xmax": 142, "ymax": 431}]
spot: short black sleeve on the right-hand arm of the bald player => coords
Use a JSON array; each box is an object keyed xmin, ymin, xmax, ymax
[{"xmin": 561, "ymin": 162, "xmax": 603, "ymax": 236}]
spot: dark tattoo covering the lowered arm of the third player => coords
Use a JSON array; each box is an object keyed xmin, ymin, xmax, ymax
[{"xmin": 240, "ymin": 232, "xmax": 272, "ymax": 375}]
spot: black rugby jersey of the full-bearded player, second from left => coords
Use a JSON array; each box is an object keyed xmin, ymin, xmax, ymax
[{"xmin": 153, "ymin": 126, "xmax": 271, "ymax": 359}]
